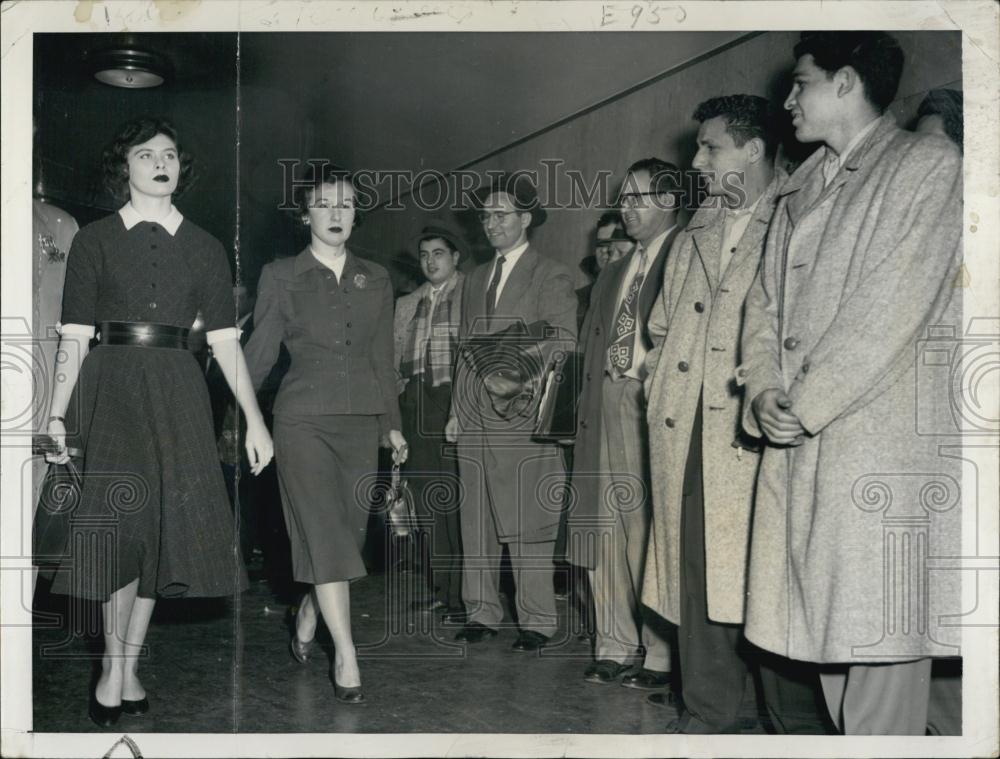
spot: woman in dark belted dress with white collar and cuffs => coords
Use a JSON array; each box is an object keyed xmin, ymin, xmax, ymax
[{"xmin": 48, "ymin": 119, "xmax": 272, "ymax": 727}]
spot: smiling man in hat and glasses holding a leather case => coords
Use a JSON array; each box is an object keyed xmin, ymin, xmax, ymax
[{"xmin": 446, "ymin": 174, "xmax": 576, "ymax": 651}]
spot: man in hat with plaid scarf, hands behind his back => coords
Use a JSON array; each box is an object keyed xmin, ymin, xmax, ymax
[{"xmin": 393, "ymin": 219, "xmax": 467, "ymax": 614}]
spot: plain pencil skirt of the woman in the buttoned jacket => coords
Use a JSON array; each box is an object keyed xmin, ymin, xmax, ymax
[{"xmin": 274, "ymin": 413, "xmax": 378, "ymax": 585}]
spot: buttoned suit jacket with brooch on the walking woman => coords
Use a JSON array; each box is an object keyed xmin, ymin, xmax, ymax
[{"xmin": 246, "ymin": 248, "xmax": 400, "ymax": 435}]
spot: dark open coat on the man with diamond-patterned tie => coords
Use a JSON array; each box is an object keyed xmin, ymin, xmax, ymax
[{"xmin": 567, "ymin": 225, "xmax": 680, "ymax": 567}]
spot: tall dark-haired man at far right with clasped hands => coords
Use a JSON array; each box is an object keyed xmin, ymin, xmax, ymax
[{"xmin": 737, "ymin": 32, "xmax": 962, "ymax": 735}]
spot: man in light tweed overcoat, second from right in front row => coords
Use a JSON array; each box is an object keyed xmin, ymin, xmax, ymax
[{"xmin": 643, "ymin": 95, "xmax": 819, "ymax": 733}]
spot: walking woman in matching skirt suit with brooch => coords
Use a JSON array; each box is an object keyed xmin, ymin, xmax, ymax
[{"xmin": 246, "ymin": 169, "xmax": 406, "ymax": 703}]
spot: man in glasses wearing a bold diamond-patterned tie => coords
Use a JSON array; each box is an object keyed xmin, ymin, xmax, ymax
[{"xmin": 567, "ymin": 158, "xmax": 680, "ymax": 690}]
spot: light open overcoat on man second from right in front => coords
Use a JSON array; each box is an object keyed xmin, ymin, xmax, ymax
[{"xmin": 642, "ymin": 183, "xmax": 776, "ymax": 624}]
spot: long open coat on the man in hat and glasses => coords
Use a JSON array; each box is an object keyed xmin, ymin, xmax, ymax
[{"xmin": 452, "ymin": 245, "xmax": 577, "ymax": 544}]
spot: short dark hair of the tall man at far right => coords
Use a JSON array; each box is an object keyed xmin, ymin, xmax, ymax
[{"xmin": 795, "ymin": 32, "xmax": 904, "ymax": 113}]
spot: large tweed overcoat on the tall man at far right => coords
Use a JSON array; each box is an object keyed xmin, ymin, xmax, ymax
[{"xmin": 739, "ymin": 115, "xmax": 975, "ymax": 663}]
